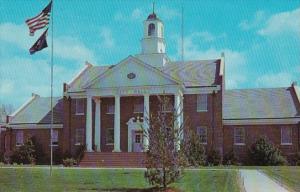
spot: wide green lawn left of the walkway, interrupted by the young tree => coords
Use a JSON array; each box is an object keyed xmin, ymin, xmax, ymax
[{"xmin": 0, "ymin": 168, "xmax": 240, "ymax": 192}]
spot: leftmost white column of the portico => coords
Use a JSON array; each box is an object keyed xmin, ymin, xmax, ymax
[{"xmin": 85, "ymin": 96, "xmax": 93, "ymax": 152}]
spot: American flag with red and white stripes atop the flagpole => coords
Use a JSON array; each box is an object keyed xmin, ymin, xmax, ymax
[{"xmin": 26, "ymin": 1, "xmax": 52, "ymax": 36}]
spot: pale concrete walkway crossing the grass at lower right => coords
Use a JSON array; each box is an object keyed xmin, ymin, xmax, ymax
[{"xmin": 240, "ymin": 169, "xmax": 288, "ymax": 192}]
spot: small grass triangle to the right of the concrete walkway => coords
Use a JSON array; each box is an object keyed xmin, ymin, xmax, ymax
[{"xmin": 262, "ymin": 166, "xmax": 300, "ymax": 191}]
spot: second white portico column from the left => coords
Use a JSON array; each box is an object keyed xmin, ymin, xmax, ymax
[{"xmin": 95, "ymin": 99, "xmax": 101, "ymax": 151}]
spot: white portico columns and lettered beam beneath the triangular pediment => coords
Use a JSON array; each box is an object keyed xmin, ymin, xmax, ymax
[{"xmin": 86, "ymin": 87, "xmax": 183, "ymax": 152}]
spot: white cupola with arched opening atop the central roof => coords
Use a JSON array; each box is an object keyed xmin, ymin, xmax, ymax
[{"xmin": 136, "ymin": 10, "xmax": 169, "ymax": 67}]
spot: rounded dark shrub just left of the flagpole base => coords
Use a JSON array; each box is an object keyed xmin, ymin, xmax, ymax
[{"xmin": 11, "ymin": 138, "xmax": 36, "ymax": 164}]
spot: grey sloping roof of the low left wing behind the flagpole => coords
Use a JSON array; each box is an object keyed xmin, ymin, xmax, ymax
[{"xmin": 9, "ymin": 95, "xmax": 63, "ymax": 125}]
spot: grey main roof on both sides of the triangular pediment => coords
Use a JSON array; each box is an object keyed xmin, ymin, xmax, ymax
[{"xmin": 68, "ymin": 57, "xmax": 220, "ymax": 92}]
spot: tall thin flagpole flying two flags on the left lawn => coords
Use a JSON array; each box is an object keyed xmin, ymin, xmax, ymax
[{"xmin": 50, "ymin": 0, "xmax": 54, "ymax": 176}]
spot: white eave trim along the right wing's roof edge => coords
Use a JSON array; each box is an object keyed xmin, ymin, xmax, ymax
[{"xmin": 223, "ymin": 118, "xmax": 300, "ymax": 125}]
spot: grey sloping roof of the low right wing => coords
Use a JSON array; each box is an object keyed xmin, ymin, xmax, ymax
[{"xmin": 223, "ymin": 87, "xmax": 300, "ymax": 120}]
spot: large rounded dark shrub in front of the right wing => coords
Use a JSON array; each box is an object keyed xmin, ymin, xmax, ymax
[{"xmin": 249, "ymin": 137, "xmax": 287, "ymax": 166}]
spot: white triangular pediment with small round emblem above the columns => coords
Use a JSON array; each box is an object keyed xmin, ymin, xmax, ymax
[{"xmin": 86, "ymin": 56, "xmax": 179, "ymax": 89}]
